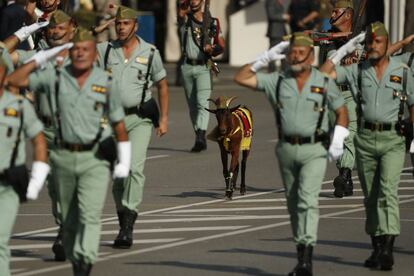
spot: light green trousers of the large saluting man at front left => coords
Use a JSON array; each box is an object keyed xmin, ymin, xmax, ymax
[{"xmin": 50, "ymin": 149, "xmax": 110, "ymax": 264}]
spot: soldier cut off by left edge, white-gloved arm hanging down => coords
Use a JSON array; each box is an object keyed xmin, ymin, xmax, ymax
[{"xmin": 0, "ymin": 57, "xmax": 49, "ymax": 276}]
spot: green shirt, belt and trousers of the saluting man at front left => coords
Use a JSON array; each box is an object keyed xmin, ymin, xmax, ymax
[{"xmin": 29, "ymin": 38, "xmax": 124, "ymax": 264}]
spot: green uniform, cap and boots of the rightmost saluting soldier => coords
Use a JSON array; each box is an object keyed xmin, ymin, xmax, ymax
[{"xmin": 336, "ymin": 23, "xmax": 414, "ymax": 270}]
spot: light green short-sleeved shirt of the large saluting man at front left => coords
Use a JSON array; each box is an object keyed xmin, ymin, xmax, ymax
[{"xmin": 29, "ymin": 65, "xmax": 124, "ymax": 144}]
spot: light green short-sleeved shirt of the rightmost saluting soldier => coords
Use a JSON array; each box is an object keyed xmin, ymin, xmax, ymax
[{"xmin": 336, "ymin": 57, "xmax": 414, "ymax": 123}]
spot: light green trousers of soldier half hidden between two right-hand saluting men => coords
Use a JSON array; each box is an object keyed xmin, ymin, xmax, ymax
[{"xmin": 336, "ymin": 91, "xmax": 357, "ymax": 170}]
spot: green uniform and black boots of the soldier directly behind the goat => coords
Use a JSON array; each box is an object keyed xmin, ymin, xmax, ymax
[{"xmin": 179, "ymin": 10, "xmax": 220, "ymax": 152}]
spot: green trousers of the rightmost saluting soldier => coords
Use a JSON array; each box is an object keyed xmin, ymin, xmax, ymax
[{"xmin": 355, "ymin": 129, "xmax": 405, "ymax": 236}]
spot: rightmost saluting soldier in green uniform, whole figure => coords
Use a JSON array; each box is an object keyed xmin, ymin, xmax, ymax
[{"xmin": 321, "ymin": 22, "xmax": 414, "ymax": 270}]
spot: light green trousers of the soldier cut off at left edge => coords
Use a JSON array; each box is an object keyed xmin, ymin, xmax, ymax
[{"xmin": 0, "ymin": 181, "xmax": 19, "ymax": 276}]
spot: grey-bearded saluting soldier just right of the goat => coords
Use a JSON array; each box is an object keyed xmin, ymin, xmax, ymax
[{"xmin": 235, "ymin": 33, "xmax": 349, "ymax": 276}]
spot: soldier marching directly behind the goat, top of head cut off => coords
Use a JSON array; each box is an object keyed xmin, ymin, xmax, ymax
[{"xmin": 178, "ymin": 0, "xmax": 224, "ymax": 152}]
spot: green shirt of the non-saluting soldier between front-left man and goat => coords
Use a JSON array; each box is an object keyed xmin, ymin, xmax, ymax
[{"xmin": 97, "ymin": 37, "xmax": 167, "ymax": 108}]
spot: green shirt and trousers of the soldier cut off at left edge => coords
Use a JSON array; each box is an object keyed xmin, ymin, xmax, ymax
[{"xmin": 0, "ymin": 90, "xmax": 43, "ymax": 276}]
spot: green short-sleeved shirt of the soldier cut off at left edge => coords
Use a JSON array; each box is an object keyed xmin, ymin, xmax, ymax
[{"xmin": 0, "ymin": 90, "xmax": 43, "ymax": 172}]
